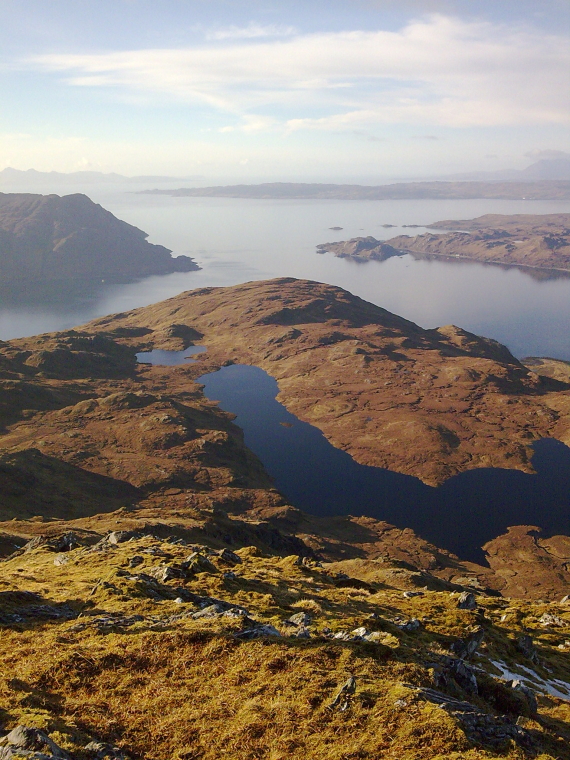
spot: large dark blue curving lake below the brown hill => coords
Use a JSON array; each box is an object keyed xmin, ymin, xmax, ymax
[{"xmin": 193, "ymin": 365, "xmax": 570, "ymax": 562}]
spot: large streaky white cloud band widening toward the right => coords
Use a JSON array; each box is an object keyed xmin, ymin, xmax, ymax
[{"xmin": 28, "ymin": 15, "xmax": 570, "ymax": 132}]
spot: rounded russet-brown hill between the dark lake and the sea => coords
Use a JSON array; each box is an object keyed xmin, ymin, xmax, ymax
[{"xmin": 79, "ymin": 278, "xmax": 570, "ymax": 485}]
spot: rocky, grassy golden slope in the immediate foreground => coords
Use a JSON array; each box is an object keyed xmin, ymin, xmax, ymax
[{"xmin": 0, "ymin": 524, "xmax": 570, "ymax": 760}]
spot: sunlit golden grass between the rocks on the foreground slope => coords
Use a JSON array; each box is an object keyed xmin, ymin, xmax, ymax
[{"xmin": 0, "ymin": 537, "xmax": 570, "ymax": 760}]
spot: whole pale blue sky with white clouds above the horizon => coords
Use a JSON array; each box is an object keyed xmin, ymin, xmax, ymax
[{"xmin": 0, "ymin": 0, "xmax": 570, "ymax": 181}]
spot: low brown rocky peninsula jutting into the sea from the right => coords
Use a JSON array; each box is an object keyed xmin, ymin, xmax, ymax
[{"xmin": 317, "ymin": 214, "xmax": 570, "ymax": 272}]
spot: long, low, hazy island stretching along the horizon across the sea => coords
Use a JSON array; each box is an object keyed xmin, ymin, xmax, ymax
[{"xmin": 140, "ymin": 180, "xmax": 570, "ymax": 201}]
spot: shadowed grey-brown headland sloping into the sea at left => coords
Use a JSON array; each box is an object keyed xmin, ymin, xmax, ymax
[{"xmin": 0, "ymin": 193, "xmax": 200, "ymax": 285}]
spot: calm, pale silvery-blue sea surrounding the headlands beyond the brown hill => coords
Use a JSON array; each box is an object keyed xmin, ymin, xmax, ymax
[{"xmin": 0, "ymin": 186, "xmax": 570, "ymax": 360}]
